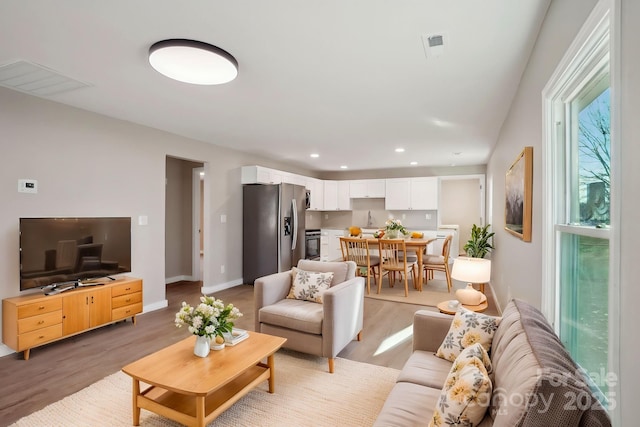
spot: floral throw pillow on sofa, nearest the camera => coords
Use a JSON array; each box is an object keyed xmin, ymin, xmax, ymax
[{"xmin": 429, "ymin": 344, "xmax": 493, "ymax": 427}]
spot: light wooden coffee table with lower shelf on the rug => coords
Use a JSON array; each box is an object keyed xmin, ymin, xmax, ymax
[{"xmin": 122, "ymin": 332, "xmax": 286, "ymax": 427}]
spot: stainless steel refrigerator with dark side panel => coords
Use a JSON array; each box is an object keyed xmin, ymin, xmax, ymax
[{"xmin": 242, "ymin": 184, "xmax": 307, "ymax": 284}]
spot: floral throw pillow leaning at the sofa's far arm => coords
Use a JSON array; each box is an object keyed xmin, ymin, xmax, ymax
[{"xmin": 436, "ymin": 307, "xmax": 501, "ymax": 362}]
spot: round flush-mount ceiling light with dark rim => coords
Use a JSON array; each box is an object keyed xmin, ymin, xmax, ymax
[{"xmin": 149, "ymin": 39, "xmax": 238, "ymax": 85}]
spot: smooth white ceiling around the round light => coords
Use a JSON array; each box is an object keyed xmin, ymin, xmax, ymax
[{"xmin": 0, "ymin": 0, "xmax": 550, "ymax": 171}]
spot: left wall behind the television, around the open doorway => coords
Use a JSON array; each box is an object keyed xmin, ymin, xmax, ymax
[{"xmin": 0, "ymin": 88, "xmax": 309, "ymax": 354}]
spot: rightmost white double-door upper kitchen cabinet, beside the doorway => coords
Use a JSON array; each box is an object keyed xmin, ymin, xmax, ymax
[{"xmin": 384, "ymin": 176, "xmax": 438, "ymax": 211}]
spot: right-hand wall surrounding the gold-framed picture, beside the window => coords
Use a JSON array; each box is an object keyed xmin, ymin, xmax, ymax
[{"xmin": 487, "ymin": 0, "xmax": 597, "ymax": 307}]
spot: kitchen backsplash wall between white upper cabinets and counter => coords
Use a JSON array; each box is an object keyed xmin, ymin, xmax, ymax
[{"xmin": 306, "ymin": 199, "xmax": 438, "ymax": 230}]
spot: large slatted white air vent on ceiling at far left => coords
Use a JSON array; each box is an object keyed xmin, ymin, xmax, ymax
[{"xmin": 0, "ymin": 60, "xmax": 90, "ymax": 96}]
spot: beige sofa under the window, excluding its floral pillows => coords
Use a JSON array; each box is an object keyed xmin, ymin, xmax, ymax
[{"xmin": 375, "ymin": 300, "xmax": 611, "ymax": 427}]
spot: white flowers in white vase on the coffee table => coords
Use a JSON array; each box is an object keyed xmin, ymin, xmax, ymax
[{"xmin": 175, "ymin": 296, "xmax": 242, "ymax": 357}]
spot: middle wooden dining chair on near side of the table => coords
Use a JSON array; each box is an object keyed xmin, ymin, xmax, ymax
[{"xmin": 378, "ymin": 239, "xmax": 418, "ymax": 297}]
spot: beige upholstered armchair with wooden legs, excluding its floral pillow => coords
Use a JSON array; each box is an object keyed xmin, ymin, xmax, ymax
[{"xmin": 254, "ymin": 260, "xmax": 364, "ymax": 373}]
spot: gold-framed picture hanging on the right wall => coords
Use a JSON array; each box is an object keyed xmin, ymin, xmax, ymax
[{"xmin": 504, "ymin": 147, "xmax": 533, "ymax": 242}]
